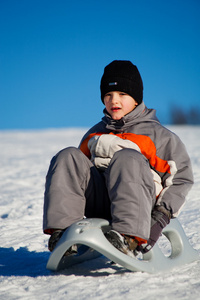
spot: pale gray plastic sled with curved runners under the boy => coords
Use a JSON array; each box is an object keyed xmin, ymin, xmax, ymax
[{"xmin": 47, "ymin": 219, "xmax": 199, "ymax": 273}]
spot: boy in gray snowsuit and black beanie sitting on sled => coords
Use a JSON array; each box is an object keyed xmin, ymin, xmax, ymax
[{"xmin": 43, "ymin": 60, "xmax": 193, "ymax": 256}]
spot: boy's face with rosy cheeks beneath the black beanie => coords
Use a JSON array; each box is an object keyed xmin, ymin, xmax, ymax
[{"xmin": 104, "ymin": 91, "xmax": 138, "ymax": 120}]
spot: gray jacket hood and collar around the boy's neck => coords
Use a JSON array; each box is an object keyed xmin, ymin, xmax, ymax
[{"xmin": 102, "ymin": 101, "xmax": 160, "ymax": 132}]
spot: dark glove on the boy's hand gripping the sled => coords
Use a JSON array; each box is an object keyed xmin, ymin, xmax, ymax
[{"xmin": 137, "ymin": 205, "xmax": 171, "ymax": 254}]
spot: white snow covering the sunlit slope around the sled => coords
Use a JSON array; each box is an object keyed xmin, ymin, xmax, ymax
[{"xmin": 0, "ymin": 126, "xmax": 200, "ymax": 300}]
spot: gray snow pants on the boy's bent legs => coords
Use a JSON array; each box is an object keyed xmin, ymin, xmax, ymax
[{"xmin": 43, "ymin": 147, "xmax": 156, "ymax": 239}]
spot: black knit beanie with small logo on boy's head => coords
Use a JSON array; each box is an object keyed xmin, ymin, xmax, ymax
[{"xmin": 100, "ymin": 60, "xmax": 143, "ymax": 104}]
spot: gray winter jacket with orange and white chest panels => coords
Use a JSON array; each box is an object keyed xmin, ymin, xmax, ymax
[{"xmin": 79, "ymin": 102, "xmax": 193, "ymax": 217}]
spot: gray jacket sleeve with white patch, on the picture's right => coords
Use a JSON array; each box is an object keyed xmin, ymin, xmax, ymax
[{"xmin": 157, "ymin": 132, "xmax": 193, "ymax": 217}]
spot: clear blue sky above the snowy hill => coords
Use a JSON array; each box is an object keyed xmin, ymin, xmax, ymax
[{"xmin": 0, "ymin": 0, "xmax": 200, "ymax": 129}]
